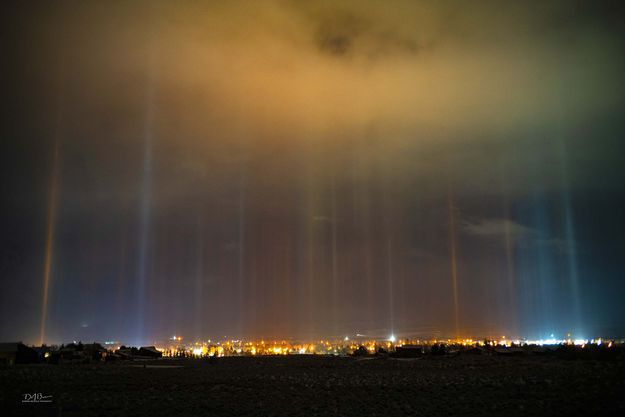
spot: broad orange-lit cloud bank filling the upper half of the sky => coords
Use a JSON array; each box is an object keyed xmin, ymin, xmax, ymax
[{"xmin": 9, "ymin": 0, "xmax": 625, "ymax": 210}]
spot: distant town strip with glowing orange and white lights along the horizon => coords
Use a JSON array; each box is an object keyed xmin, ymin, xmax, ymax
[{"xmin": 0, "ymin": 336, "xmax": 625, "ymax": 365}]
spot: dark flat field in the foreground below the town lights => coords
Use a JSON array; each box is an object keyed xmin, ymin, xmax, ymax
[{"xmin": 0, "ymin": 356, "xmax": 625, "ymax": 416}]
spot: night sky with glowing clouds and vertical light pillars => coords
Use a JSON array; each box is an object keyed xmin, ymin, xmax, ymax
[{"xmin": 0, "ymin": 0, "xmax": 625, "ymax": 343}]
